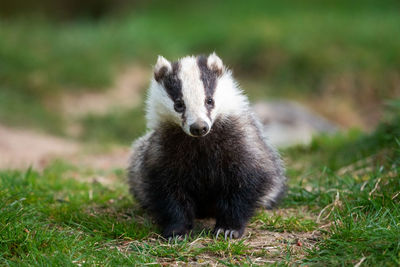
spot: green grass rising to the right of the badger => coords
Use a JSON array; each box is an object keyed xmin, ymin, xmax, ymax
[{"xmin": 284, "ymin": 104, "xmax": 400, "ymax": 266}]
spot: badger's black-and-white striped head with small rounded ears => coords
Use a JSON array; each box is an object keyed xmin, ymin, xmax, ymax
[{"xmin": 147, "ymin": 53, "xmax": 247, "ymax": 137}]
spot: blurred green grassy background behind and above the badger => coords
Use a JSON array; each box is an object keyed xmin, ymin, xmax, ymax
[{"xmin": 0, "ymin": 0, "xmax": 400, "ymax": 143}]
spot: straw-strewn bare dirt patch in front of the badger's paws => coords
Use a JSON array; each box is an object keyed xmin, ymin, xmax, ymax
[{"xmin": 107, "ymin": 209, "xmax": 321, "ymax": 266}]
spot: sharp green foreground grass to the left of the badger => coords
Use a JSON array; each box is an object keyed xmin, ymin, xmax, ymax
[{"xmin": 0, "ymin": 164, "xmax": 153, "ymax": 265}]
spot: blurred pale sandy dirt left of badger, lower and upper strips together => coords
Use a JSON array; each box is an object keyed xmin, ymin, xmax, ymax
[{"xmin": 0, "ymin": 66, "xmax": 144, "ymax": 170}]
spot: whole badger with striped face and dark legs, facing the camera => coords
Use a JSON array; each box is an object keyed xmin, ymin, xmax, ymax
[{"xmin": 128, "ymin": 53, "xmax": 286, "ymax": 239}]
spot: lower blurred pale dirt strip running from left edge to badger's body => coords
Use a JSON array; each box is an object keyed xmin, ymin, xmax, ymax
[{"xmin": 0, "ymin": 125, "xmax": 130, "ymax": 171}]
